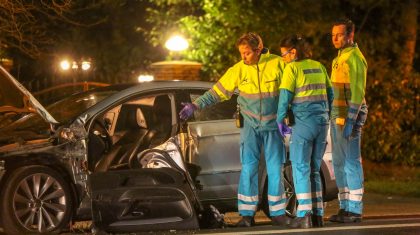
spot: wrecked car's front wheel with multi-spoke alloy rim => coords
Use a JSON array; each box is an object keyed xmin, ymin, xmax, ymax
[{"xmin": 1, "ymin": 165, "xmax": 73, "ymax": 234}]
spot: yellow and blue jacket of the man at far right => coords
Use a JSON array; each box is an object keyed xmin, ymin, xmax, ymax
[{"xmin": 331, "ymin": 44, "xmax": 367, "ymax": 120}]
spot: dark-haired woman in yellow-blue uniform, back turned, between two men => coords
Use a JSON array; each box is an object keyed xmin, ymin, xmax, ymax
[{"xmin": 277, "ymin": 35, "xmax": 333, "ymax": 228}]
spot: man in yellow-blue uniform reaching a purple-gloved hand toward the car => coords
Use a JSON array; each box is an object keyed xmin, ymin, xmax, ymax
[{"xmin": 180, "ymin": 33, "xmax": 289, "ymax": 227}]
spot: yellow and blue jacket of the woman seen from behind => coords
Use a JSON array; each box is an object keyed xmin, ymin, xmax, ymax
[{"xmin": 277, "ymin": 59, "xmax": 333, "ymax": 122}]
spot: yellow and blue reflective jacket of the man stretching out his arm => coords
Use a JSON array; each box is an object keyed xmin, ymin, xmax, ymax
[{"xmin": 194, "ymin": 52, "xmax": 284, "ymax": 130}]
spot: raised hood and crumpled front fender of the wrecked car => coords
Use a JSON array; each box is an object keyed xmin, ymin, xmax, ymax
[{"xmin": 0, "ymin": 67, "xmax": 87, "ymax": 191}]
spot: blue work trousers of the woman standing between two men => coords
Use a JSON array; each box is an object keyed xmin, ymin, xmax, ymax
[{"xmin": 290, "ymin": 114, "xmax": 328, "ymax": 217}]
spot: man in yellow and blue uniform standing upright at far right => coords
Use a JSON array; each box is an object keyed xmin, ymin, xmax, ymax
[{"xmin": 329, "ymin": 19, "xmax": 367, "ymax": 223}]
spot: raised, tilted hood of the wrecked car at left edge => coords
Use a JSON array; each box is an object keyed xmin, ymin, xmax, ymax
[{"xmin": 0, "ymin": 66, "xmax": 58, "ymax": 124}]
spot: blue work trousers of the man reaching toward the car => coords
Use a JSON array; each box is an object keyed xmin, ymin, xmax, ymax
[{"xmin": 238, "ymin": 121, "xmax": 286, "ymax": 216}]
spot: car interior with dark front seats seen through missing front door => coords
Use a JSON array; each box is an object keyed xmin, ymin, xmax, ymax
[{"xmin": 88, "ymin": 94, "xmax": 172, "ymax": 172}]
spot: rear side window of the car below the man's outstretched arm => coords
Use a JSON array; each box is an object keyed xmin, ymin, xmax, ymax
[{"xmin": 191, "ymin": 94, "xmax": 238, "ymax": 121}]
